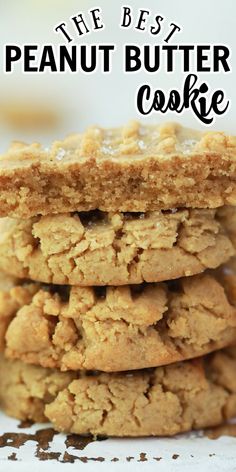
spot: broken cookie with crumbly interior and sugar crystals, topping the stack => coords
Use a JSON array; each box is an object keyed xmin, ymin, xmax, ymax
[{"xmin": 0, "ymin": 122, "xmax": 236, "ymax": 218}]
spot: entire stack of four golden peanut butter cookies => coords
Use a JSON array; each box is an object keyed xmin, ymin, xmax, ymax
[{"xmin": 0, "ymin": 123, "xmax": 236, "ymax": 436}]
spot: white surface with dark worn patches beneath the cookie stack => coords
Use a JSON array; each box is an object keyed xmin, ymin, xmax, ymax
[{"xmin": 0, "ymin": 414, "xmax": 236, "ymax": 472}]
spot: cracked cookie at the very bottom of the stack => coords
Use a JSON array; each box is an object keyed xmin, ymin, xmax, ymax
[{"xmin": 0, "ymin": 347, "xmax": 236, "ymax": 436}]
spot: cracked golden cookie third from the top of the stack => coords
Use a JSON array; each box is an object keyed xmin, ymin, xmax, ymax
[{"xmin": 2, "ymin": 269, "xmax": 236, "ymax": 372}]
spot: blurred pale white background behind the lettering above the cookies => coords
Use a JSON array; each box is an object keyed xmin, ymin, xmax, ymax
[{"xmin": 0, "ymin": 0, "xmax": 236, "ymax": 149}]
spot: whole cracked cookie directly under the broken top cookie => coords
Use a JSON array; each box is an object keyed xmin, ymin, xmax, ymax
[{"xmin": 0, "ymin": 209, "xmax": 233, "ymax": 286}]
